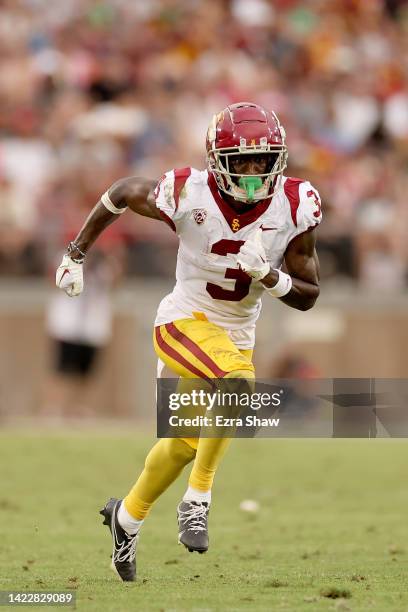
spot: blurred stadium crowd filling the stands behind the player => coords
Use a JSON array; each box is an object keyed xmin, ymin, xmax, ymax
[{"xmin": 0, "ymin": 0, "xmax": 408, "ymax": 291}]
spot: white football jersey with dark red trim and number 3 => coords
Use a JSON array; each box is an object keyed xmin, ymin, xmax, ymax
[{"xmin": 155, "ymin": 168, "xmax": 321, "ymax": 348}]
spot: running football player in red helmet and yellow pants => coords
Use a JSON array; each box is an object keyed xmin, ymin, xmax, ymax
[{"xmin": 56, "ymin": 102, "xmax": 321, "ymax": 581}]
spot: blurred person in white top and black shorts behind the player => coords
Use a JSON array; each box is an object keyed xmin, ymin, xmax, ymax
[{"xmin": 43, "ymin": 247, "xmax": 122, "ymax": 417}]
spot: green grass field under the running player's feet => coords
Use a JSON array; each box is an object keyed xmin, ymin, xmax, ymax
[{"xmin": 0, "ymin": 430, "xmax": 408, "ymax": 612}]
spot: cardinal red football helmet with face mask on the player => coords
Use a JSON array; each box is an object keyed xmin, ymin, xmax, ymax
[{"xmin": 206, "ymin": 102, "xmax": 288, "ymax": 202}]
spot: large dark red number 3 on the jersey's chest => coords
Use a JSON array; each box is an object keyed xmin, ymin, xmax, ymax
[{"xmin": 206, "ymin": 238, "xmax": 252, "ymax": 302}]
